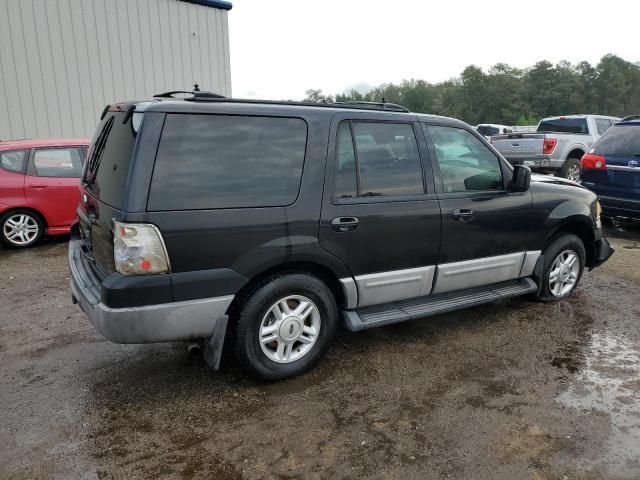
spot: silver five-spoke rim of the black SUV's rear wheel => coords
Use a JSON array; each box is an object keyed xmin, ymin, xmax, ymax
[{"xmin": 259, "ymin": 295, "xmax": 322, "ymax": 363}]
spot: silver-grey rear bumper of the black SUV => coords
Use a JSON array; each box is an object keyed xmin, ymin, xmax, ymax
[{"xmin": 69, "ymin": 240, "xmax": 234, "ymax": 343}]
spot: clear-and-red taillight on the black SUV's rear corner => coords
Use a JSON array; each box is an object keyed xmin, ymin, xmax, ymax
[{"xmin": 113, "ymin": 221, "xmax": 169, "ymax": 275}]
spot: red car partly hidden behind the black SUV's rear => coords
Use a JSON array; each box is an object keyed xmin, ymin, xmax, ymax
[{"xmin": 0, "ymin": 138, "xmax": 89, "ymax": 247}]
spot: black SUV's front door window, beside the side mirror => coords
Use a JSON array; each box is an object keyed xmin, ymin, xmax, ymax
[{"xmin": 428, "ymin": 125, "xmax": 504, "ymax": 193}]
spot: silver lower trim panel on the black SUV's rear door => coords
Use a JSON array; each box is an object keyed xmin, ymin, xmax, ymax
[{"xmin": 355, "ymin": 266, "xmax": 436, "ymax": 307}]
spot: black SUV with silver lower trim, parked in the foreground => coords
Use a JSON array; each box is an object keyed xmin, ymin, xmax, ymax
[{"xmin": 69, "ymin": 92, "xmax": 613, "ymax": 380}]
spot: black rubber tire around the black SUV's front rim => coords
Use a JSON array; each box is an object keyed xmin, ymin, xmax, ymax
[{"xmin": 535, "ymin": 234, "xmax": 587, "ymax": 302}]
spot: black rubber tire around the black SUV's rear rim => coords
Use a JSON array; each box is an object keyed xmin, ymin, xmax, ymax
[{"xmin": 232, "ymin": 272, "xmax": 338, "ymax": 381}]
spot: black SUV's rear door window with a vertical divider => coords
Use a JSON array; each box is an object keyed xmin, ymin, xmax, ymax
[{"xmin": 334, "ymin": 121, "xmax": 424, "ymax": 198}]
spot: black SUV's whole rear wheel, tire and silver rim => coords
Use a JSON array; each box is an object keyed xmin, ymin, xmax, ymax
[{"xmin": 235, "ymin": 273, "xmax": 338, "ymax": 380}]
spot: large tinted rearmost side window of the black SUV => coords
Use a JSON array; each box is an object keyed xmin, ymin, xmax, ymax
[{"xmin": 147, "ymin": 114, "xmax": 307, "ymax": 211}]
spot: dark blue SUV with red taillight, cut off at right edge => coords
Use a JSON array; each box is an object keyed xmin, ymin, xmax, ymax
[{"xmin": 581, "ymin": 115, "xmax": 640, "ymax": 220}]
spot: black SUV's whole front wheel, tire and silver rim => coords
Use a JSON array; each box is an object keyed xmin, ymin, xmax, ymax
[{"xmin": 536, "ymin": 234, "xmax": 586, "ymax": 302}]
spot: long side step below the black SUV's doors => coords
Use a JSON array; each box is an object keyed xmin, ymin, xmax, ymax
[{"xmin": 342, "ymin": 278, "xmax": 538, "ymax": 332}]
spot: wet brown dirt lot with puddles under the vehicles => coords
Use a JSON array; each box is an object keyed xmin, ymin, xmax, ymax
[{"xmin": 0, "ymin": 229, "xmax": 640, "ymax": 480}]
